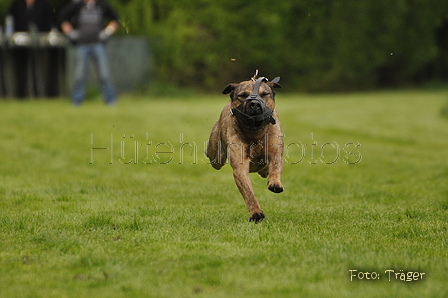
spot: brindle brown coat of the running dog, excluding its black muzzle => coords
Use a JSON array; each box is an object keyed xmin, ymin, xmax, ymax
[{"xmin": 207, "ymin": 80, "xmax": 283, "ymax": 223}]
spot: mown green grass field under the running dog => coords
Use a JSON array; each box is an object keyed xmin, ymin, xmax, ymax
[{"xmin": 0, "ymin": 90, "xmax": 448, "ymax": 298}]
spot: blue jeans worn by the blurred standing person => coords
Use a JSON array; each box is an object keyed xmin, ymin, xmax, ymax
[{"xmin": 71, "ymin": 43, "xmax": 116, "ymax": 105}]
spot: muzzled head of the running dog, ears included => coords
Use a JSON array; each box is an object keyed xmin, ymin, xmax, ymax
[{"xmin": 222, "ymin": 77, "xmax": 282, "ymax": 129}]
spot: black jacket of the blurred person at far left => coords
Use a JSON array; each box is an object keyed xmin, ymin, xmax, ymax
[{"xmin": 8, "ymin": 0, "xmax": 54, "ymax": 32}]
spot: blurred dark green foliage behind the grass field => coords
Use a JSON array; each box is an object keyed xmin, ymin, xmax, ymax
[{"xmin": 0, "ymin": 0, "xmax": 448, "ymax": 91}]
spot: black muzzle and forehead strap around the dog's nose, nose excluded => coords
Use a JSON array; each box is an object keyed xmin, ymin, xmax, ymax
[{"xmin": 230, "ymin": 77, "xmax": 275, "ymax": 129}]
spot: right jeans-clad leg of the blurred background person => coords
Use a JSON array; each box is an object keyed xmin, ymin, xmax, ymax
[{"xmin": 93, "ymin": 43, "xmax": 116, "ymax": 105}]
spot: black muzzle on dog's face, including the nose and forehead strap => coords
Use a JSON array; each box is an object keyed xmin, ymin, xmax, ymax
[{"xmin": 231, "ymin": 78, "xmax": 275, "ymax": 129}]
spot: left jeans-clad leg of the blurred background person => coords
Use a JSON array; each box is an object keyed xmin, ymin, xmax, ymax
[{"xmin": 71, "ymin": 45, "xmax": 89, "ymax": 105}]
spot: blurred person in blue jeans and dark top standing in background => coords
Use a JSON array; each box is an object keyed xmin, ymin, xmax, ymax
[{"xmin": 60, "ymin": 0, "xmax": 119, "ymax": 106}]
